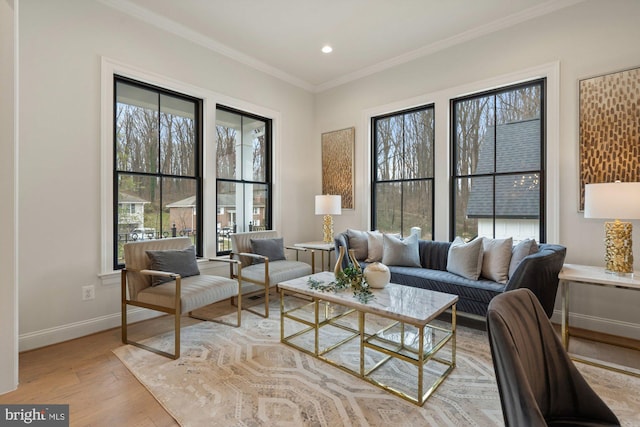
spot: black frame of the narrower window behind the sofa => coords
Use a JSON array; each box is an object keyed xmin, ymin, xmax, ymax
[{"xmin": 370, "ymin": 103, "xmax": 436, "ymax": 240}]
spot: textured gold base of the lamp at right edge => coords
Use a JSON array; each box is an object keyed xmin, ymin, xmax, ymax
[{"xmin": 604, "ymin": 220, "xmax": 633, "ymax": 276}]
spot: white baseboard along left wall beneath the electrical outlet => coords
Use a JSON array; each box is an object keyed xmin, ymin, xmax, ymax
[{"xmin": 18, "ymin": 308, "xmax": 163, "ymax": 351}]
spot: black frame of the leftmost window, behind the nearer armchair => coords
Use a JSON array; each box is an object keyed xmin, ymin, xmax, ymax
[{"xmin": 112, "ymin": 74, "xmax": 204, "ymax": 270}]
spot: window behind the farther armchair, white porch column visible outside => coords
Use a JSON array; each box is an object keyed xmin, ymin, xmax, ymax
[{"xmin": 216, "ymin": 105, "xmax": 271, "ymax": 254}]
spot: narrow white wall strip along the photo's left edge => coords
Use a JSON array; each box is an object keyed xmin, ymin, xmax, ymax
[{"xmin": 0, "ymin": 0, "xmax": 18, "ymax": 394}]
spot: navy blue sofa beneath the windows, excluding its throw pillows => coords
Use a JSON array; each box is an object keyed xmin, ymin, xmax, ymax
[{"xmin": 334, "ymin": 232, "xmax": 567, "ymax": 317}]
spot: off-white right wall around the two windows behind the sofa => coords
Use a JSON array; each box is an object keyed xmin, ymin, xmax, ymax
[{"xmin": 314, "ymin": 0, "xmax": 640, "ymax": 338}]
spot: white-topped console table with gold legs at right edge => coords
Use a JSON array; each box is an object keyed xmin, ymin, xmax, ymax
[{"xmin": 558, "ymin": 264, "xmax": 640, "ymax": 377}]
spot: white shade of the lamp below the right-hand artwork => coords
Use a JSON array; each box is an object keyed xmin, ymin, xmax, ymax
[{"xmin": 584, "ymin": 182, "xmax": 640, "ymax": 219}]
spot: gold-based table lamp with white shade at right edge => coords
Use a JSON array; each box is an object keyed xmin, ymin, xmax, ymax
[{"xmin": 584, "ymin": 181, "xmax": 640, "ymax": 276}]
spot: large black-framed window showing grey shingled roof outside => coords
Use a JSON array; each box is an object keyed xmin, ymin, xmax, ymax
[{"xmin": 450, "ymin": 79, "xmax": 546, "ymax": 242}]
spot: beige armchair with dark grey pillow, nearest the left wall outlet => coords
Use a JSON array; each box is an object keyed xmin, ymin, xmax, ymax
[{"xmin": 121, "ymin": 237, "xmax": 242, "ymax": 359}]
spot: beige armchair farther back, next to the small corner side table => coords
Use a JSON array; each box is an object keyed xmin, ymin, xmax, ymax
[{"xmin": 230, "ymin": 230, "xmax": 315, "ymax": 317}]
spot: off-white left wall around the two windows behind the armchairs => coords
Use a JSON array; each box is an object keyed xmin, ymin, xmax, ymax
[{"xmin": 18, "ymin": 0, "xmax": 320, "ymax": 350}]
